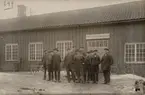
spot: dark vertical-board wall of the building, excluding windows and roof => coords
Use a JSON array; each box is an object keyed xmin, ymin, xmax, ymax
[{"xmin": 0, "ymin": 22, "xmax": 145, "ymax": 75}]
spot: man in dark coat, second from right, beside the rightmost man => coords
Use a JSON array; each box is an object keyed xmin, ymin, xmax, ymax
[{"xmin": 91, "ymin": 50, "xmax": 100, "ymax": 83}]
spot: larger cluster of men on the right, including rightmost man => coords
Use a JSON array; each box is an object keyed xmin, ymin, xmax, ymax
[{"xmin": 64, "ymin": 47, "xmax": 113, "ymax": 84}]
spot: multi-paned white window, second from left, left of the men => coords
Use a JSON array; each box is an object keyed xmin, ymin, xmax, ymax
[{"xmin": 29, "ymin": 42, "xmax": 43, "ymax": 61}]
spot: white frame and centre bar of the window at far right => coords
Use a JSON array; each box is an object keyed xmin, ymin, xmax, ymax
[{"xmin": 124, "ymin": 42, "xmax": 145, "ymax": 64}]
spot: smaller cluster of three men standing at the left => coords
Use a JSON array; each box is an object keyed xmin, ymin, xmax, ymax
[{"xmin": 42, "ymin": 49, "xmax": 61, "ymax": 82}]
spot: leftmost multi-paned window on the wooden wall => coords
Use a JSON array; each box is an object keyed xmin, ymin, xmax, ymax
[{"xmin": 5, "ymin": 44, "xmax": 19, "ymax": 61}]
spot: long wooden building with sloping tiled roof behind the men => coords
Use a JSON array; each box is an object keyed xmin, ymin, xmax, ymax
[{"xmin": 0, "ymin": 1, "xmax": 145, "ymax": 76}]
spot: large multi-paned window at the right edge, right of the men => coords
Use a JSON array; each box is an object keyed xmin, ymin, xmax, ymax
[{"xmin": 125, "ymin": 43, "xmax": 145, "ymax": 63}]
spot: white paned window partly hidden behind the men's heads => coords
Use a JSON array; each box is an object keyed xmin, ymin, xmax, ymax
[{"xmin": 56, "ymin": 41, "xmax": 73, "ymax": 60}]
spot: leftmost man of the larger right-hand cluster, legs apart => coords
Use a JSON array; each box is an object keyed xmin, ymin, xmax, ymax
[{"xmin": 64, "ymin": 49, "xmax": 75, "ymax": 82}]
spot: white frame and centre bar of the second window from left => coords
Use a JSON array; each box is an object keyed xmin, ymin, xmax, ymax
[{"xmin": 28, "ymin": 42, "xmax": 43, "ymax": 61}]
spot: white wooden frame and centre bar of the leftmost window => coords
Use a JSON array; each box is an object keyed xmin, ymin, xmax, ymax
[{"xmin": 5, "ymin": 43, "xmax": 19, "ymax": 61}]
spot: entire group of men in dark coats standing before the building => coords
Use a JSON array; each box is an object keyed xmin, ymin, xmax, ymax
[{"xmin": 42, "ymin": 47, "xmax": 113, "ymax": 84}]
